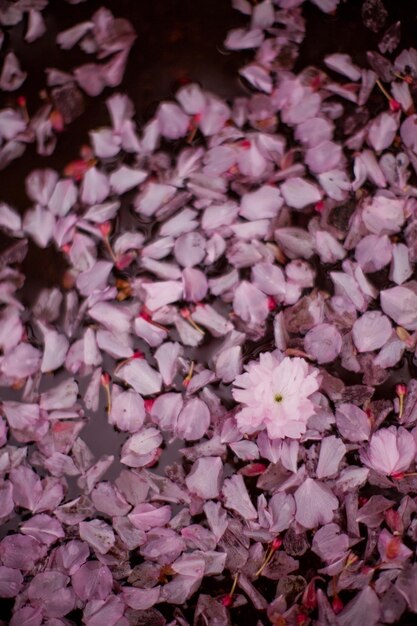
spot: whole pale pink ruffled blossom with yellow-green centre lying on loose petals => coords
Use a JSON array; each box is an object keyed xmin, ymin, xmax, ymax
[{"xmin": 233, "ymin": 352, "xmax": 319, "ymax": 439}]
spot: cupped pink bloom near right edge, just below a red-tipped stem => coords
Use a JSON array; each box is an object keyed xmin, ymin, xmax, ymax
[{"xmin": 361, "ymin": 426, "xmax": 416, "ymax": 476}]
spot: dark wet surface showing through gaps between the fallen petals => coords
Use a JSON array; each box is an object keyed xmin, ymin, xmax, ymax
[{"xmin": 0, "ymin": 0, "xmax": 417, "ymax": 626}]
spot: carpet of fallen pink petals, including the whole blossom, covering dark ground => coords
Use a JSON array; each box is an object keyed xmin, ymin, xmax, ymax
[{"xmin": 0, "ymin": 0, "xmax": 417, "ymax": 626}]
